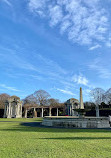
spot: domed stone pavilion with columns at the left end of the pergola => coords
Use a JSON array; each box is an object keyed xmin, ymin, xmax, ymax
[{"xmin": 4, "ymin": 96, "xmax": 22, "ymax": 118}]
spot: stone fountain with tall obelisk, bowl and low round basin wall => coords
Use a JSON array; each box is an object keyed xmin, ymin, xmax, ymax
[{"xmin": 42, "ymin": 88, "xmax": 110, "ymax": 128}]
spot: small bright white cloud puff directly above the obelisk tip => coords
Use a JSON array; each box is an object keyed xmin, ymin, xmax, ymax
[{"xmin": 72, "ymin": 75, "xmax": 89, "ymax": 86}]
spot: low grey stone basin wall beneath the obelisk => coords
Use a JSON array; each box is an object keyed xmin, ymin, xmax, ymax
[{"xmin": 42, "ymin": 117, "xmax": 110, "ymax": 128}]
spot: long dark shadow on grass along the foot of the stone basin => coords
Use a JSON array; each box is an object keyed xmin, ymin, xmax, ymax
[{"xmin": 0, "ymin": 122, "xmax": 111, "ymax": 133}]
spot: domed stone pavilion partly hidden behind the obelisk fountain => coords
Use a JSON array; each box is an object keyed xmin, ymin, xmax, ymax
[{"xmin": 65, "ymin": 98, "xmax": 79, "ymax": 116}]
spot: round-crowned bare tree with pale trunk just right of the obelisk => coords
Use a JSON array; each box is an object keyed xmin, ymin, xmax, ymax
[{"xmin": 90, "ymin": 88, "xmax": 105, "ymax": 117}]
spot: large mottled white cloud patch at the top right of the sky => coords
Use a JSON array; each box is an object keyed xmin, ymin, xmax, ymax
[{"xmin": 28, "ymin": 0, "xmax": 108, "ymax": 45}]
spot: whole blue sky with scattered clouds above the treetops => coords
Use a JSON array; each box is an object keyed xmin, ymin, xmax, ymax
[{"xmin": 0, "ymin": 0, "xmax": 111, "ymax": 101}]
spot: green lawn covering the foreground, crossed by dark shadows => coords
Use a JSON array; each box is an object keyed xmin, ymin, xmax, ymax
[{"xmin": 0, "ymin": 119, "xmax": 111, "ymax": 158}]
